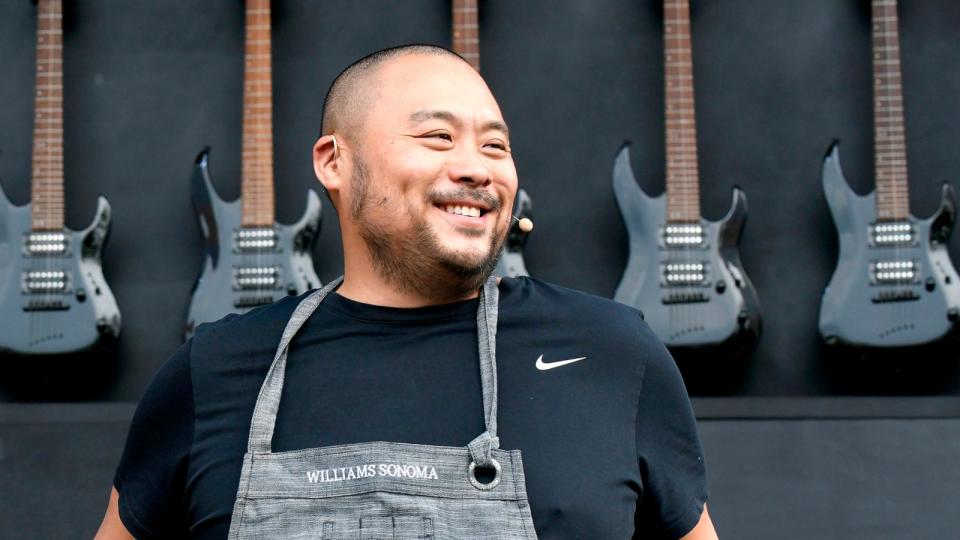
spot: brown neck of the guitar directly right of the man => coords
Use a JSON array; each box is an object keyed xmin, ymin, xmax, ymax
[{"xmin": 663, "ymin": 0, "xmax": 700, "ymax": 222}]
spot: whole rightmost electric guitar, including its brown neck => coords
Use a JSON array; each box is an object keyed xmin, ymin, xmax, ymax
[{"xmin": 820, "ymin": 0, "xmax": 960, "ymax": 349}]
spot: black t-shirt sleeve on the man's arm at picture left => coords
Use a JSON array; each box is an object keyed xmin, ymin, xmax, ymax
[{"xmin": 113, "ymin": 341, "xmax": 193, "ymax": 540}]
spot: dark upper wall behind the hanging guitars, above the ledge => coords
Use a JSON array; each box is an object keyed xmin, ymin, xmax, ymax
[{"xmin": 0, "ymin": 0, "xmax": 960, "ymax": 400}]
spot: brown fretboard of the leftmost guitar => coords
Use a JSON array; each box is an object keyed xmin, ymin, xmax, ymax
[{"xmin": 30, "ymin": 0, "xmax": 63, "ymax": 231}]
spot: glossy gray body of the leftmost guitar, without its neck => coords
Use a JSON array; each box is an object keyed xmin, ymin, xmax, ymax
[{"xmin": 0, "ymin": 184, "xmax": 120, "ymax": 355}]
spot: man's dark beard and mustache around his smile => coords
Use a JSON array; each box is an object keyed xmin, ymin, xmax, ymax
[{"xmin": 350, "ymin": 154, "xmax": 506, "ymax": 302}]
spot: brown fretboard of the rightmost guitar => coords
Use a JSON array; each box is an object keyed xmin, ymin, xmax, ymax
[{"xmin": 872, "ymin": 0, "xmax": 910, "ymax": 221}]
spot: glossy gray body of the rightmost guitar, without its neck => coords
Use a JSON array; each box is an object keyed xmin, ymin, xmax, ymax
[{"xmin": 820, "ymin": 143, "xmax": 960, "ymax": 349}]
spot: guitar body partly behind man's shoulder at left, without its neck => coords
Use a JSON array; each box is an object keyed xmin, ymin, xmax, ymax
[{"xmin": 184, "ymin": 149, "xmax": 320, "ymax": 338}]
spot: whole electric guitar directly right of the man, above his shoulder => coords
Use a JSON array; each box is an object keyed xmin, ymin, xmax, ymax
[{"xmin": 613, "ymin": 0, "xmax": 761, "ymax": 355}]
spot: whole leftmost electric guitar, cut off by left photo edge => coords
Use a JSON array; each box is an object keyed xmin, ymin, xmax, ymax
[{"xmin": 0, "ymin": 0, "xmax": 120, "ymax": 355}]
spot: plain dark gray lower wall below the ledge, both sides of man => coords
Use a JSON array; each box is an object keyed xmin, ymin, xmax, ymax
[{"xmin": 0, "ymin": 404, "xmax": 960, "ymax": 540}]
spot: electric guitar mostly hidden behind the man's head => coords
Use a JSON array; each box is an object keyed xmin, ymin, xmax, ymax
[{"xmin": 451, "ymin": 0, "xmax": 533, "ymax": 277}]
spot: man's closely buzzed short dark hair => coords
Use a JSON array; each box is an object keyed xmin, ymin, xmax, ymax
[{"xmin": 320, "ymin": 44, "xmax": 469, "ymax": 141}]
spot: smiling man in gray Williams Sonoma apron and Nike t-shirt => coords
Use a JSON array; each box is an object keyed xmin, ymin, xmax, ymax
[{"xmin": 98, "ymin": 46, "xmax": 716, "ymax": 540}]
